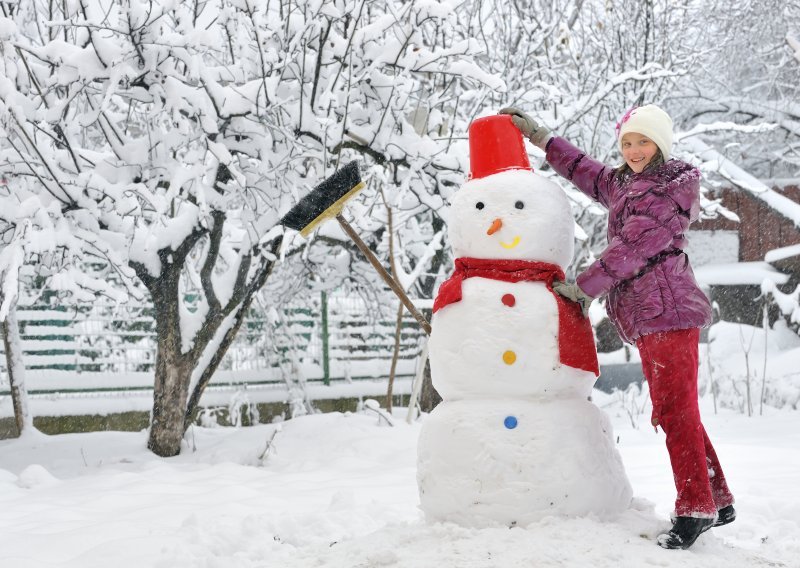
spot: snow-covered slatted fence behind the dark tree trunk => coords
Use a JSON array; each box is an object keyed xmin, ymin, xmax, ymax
[{"xmin": 0, "ymin": 294, "xmax": 424, "ymax": 394}]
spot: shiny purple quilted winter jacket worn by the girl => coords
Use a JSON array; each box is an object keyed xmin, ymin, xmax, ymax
[{"xmin": 547, "ymin": 137, "xmax": 711, "ymax": 343}]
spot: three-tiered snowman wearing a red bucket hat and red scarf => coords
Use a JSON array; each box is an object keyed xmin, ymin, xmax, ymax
[{"xmin": 417, "ymin": 115, "xmax": 632, "ymax": 526}]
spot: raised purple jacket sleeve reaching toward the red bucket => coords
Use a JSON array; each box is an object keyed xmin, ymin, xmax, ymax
[{"xmin": 546, "ymin": 136, "xmax": 614, "ymax": 207}]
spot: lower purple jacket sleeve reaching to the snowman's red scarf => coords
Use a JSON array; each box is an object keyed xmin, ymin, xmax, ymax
[{"xmin": 577, "ymin": 183, "xmax": 689, "ymax": 298}]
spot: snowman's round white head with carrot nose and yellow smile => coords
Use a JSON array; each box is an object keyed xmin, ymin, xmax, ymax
[{"xmin": 448, "ymin": 169, "xmax": 575, "ymax": 269}]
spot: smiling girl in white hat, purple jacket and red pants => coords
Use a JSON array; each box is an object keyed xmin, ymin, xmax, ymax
[{"xmin": 500, "ymin": 105, "xmax": 736, "ymax": 548}]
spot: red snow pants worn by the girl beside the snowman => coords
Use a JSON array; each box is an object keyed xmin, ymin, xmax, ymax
[{"xmin": 636, "ymin": 329, "xmax": 733, "ymax": 518}]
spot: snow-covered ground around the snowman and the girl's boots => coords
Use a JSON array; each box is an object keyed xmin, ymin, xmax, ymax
[{"xmin": 0, "ymin": 391, "xmax": 800, "ymax": 568}]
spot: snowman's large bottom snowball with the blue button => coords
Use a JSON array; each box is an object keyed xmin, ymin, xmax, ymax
[{"xmin": 417, "ymin": 399, "xmax": 633, "ymax": 527}]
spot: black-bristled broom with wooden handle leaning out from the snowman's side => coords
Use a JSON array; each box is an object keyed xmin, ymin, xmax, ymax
[{"xmin": 280, "ymin": 162, "xmax": 431, "ymax": 335}]
